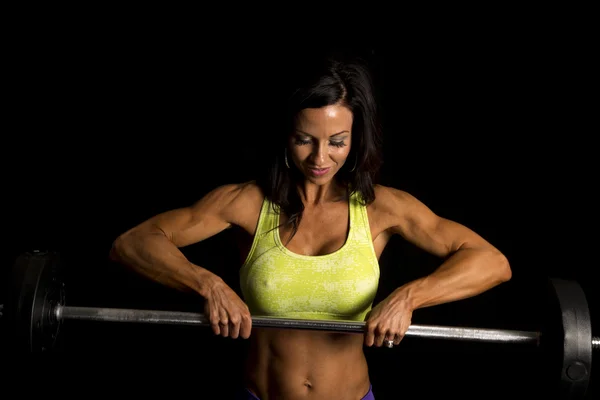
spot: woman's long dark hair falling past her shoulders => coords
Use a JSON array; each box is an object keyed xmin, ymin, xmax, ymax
[{"xmin": 256, "ymin": 50, "xmax": 382, "ymax": 238}]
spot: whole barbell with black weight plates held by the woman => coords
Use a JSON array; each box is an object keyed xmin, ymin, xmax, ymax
[{"xmin": 0, "ymin": 251, "xmax": 600, "ymax": 399}]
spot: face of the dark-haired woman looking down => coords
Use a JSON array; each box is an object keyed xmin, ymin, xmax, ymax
[{"xmin": 289, "ymin": 105, "xmax": 353, "ymax": 185}]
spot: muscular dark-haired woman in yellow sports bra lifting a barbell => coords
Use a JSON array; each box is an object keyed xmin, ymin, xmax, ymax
[{"xmin": 112, "ymin": 53, "xmax": 511, "ymax": 400}]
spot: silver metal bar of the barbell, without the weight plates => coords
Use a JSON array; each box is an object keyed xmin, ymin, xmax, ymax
[{"xmin": 55, "ymin": 305, "xmax": 540, "ymax": 345}]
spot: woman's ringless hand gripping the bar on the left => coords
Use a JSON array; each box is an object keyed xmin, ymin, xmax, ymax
[{"xmin": 204, "ymin": 279, "xmax": 252, "ymax": 339}]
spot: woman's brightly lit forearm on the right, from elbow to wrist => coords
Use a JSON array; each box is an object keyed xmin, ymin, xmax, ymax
[{"xmin": 394, "ymin": 249, "xmax": 511, "ymax": 310}]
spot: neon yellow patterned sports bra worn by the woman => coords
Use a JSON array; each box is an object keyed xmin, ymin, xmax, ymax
[{"xmin": 240, "ymin": 193, "xmax": 379, "ymax": 321}]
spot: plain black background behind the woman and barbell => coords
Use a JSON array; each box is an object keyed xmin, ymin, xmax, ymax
[{"xmin": 2, "ymin": 7, "xmax": 600, "ymax": 400}]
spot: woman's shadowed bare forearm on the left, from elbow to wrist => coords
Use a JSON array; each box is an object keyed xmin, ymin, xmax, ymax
[{"xmin": 110, "ymin": 231, "xmax": 220, "ymax": 296}]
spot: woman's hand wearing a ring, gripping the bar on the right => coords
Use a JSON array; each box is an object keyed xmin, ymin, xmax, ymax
[{"xmin": 365, "ymin": 290, "xmax": 413, "ymax": 347}]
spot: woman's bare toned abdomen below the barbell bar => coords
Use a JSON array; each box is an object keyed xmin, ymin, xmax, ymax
[{"xmin": 245, "ymin": 328, "xmax": 370, "ymax": 400}]
